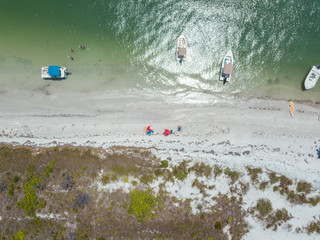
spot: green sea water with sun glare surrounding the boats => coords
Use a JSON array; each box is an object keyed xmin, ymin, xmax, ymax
[{"xmin": 0, "ymin": 0, "xmax": 320, "ymax": 101}]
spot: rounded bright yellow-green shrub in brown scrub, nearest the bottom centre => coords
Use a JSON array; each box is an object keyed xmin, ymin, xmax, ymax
[{"xmin": 128, "ymin": 188, "xmax": 159, "ymax": 222}]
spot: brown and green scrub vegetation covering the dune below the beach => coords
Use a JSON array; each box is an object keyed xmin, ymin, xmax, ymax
[{"xmin": 0, "ymin": 143, "xmax": 312, "ymax": 239}]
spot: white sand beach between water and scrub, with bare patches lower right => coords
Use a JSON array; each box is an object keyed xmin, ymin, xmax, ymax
[{"xmin": 0, "ymin": 86, "xmax": 320, "ymax": 239}]
